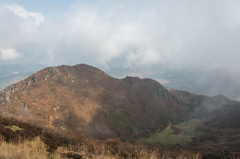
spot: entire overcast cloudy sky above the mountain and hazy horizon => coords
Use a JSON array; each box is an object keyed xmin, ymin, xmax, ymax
[{"xmin": 0, "ymin": 0, "xmax": 240, "ymax": 77}]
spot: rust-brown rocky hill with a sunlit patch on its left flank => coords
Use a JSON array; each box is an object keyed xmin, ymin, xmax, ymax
[{"xmin": 0, "ymin": 64, "xmax": 190, "ymax": 138}]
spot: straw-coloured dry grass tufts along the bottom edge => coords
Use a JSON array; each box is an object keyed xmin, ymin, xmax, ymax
[{"xmin": 0, "ymin": 137, "xmax": 204, "ymax": 159}]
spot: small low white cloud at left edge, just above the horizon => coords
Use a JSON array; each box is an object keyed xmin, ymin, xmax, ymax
[{"xmin": 0, "ymin": 48, "xmax": 21, "ymax": 61}]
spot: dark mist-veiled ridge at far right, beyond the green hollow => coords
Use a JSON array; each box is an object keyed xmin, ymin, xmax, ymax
[{"xmin": 169, "ymin": 89, "xmax": 240, "ymax": 128}]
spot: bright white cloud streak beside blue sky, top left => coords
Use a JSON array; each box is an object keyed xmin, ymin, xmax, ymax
[{"xmin": 7, "ymin": 4, "xmax": 44, "ymax": 25}]
